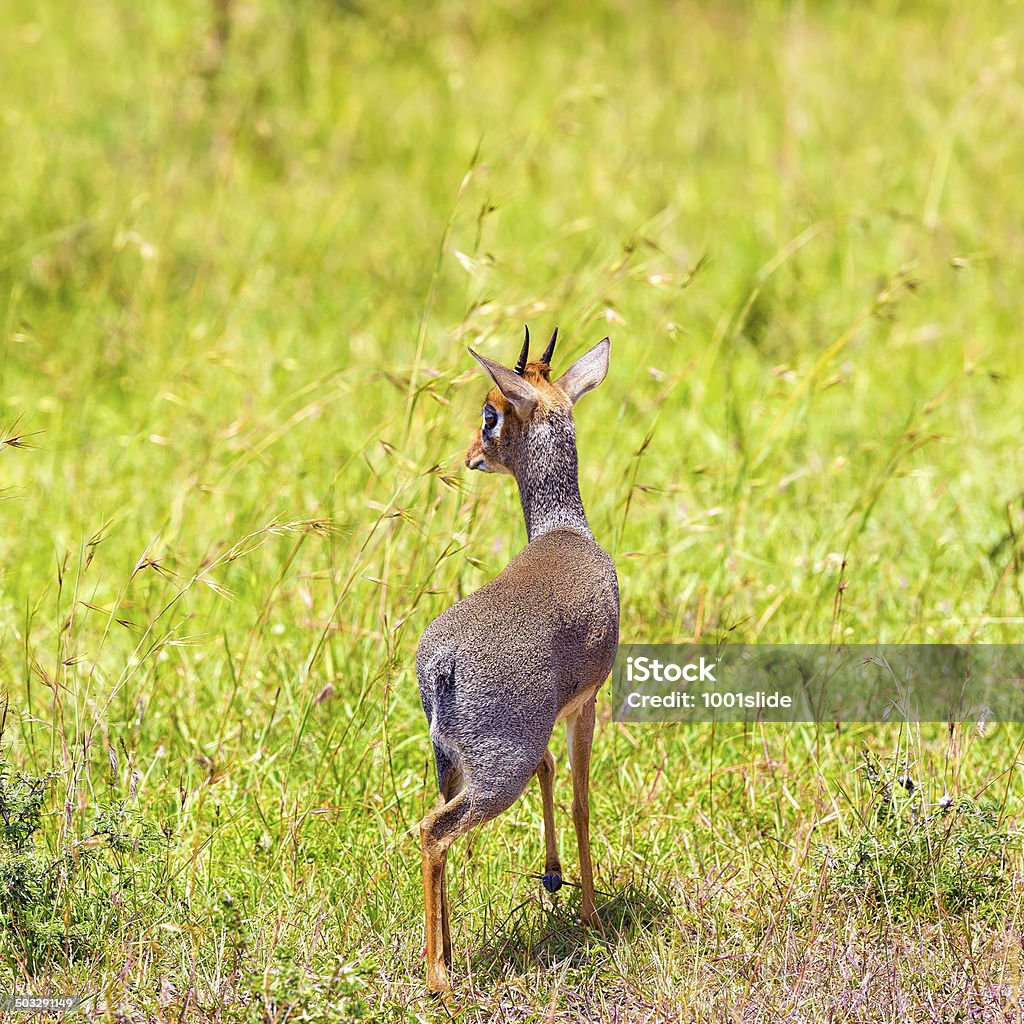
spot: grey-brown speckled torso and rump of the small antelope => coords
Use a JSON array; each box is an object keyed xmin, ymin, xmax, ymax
[{"xmin": 416, "ymin": 529, "xmax": 618, "ymax": 799}]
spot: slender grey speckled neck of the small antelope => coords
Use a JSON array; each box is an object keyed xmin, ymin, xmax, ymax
[{"xmin": 515, "ymin": 413, "xmax": 593, "ymax": 541}]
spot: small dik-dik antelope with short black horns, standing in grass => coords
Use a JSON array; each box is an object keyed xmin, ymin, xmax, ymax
[{"xmin": 416, "ymin": 329, "xmax": 618, "ymax": 992}]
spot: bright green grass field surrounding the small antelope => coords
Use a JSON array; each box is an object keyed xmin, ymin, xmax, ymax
[{"xmin": 0, "ymin": 0, "xmax": 1024, "ymax": 1022}]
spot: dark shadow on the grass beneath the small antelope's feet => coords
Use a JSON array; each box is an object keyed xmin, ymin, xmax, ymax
[{"xmin": 472, "ymin": 877, "xmax": 673, "ymax": 984}]
